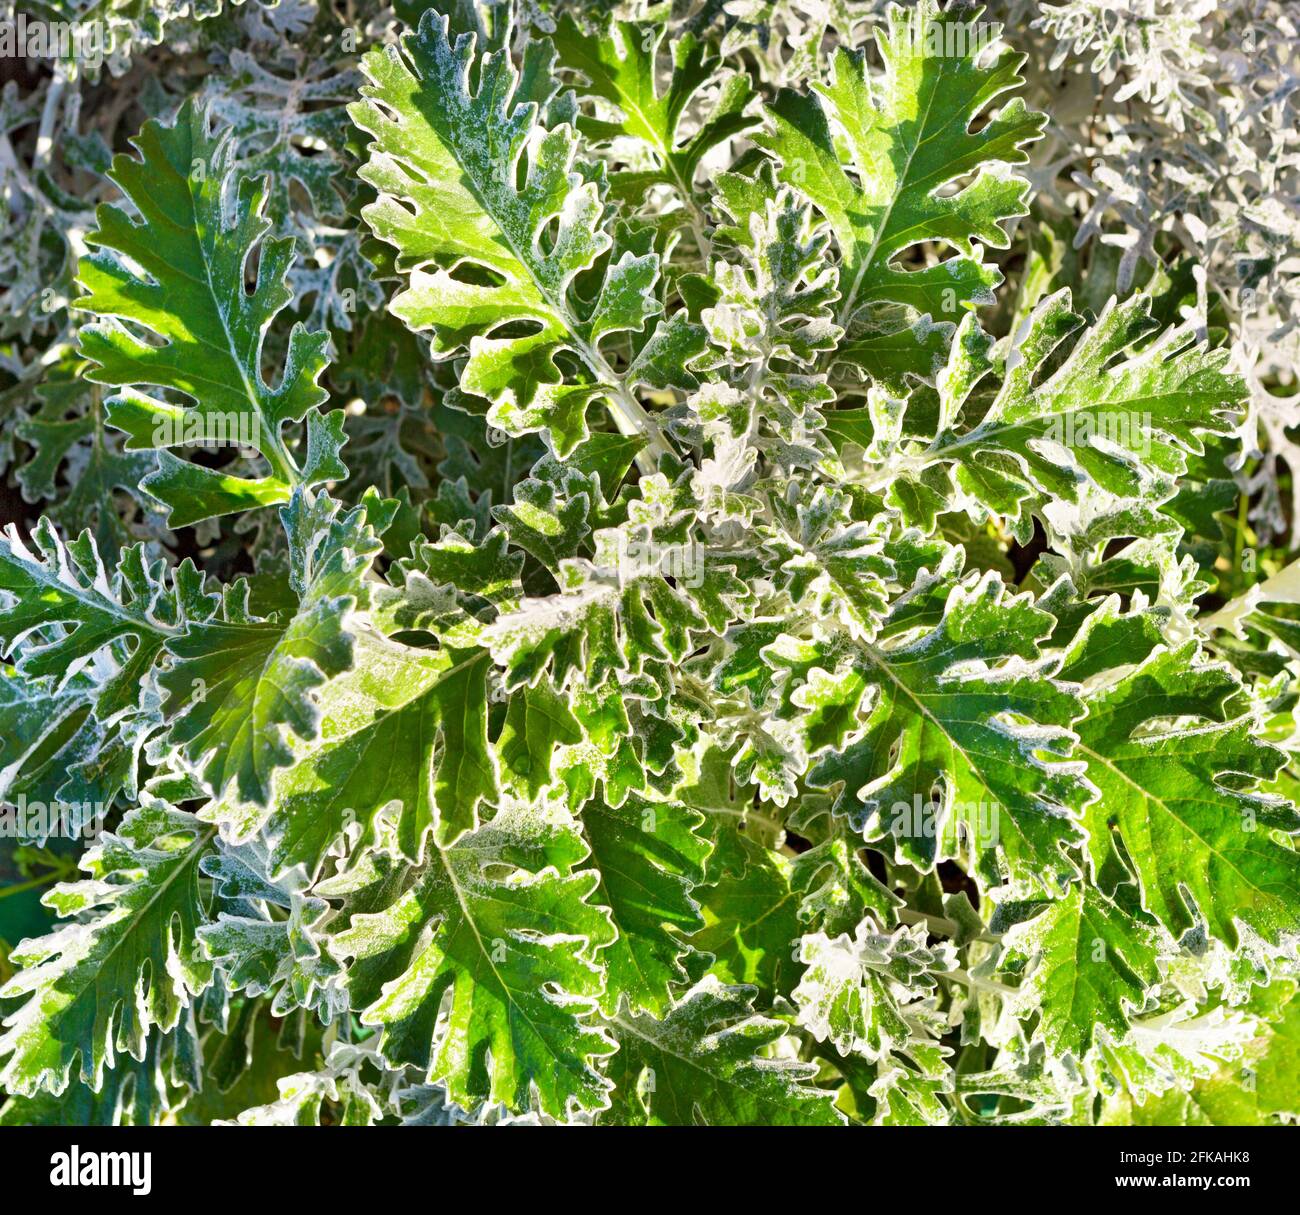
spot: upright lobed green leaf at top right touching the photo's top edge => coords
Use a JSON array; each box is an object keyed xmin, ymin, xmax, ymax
[{"xmin": 757, "ymin": 0, "xmax": 1047, "ymax": 386}]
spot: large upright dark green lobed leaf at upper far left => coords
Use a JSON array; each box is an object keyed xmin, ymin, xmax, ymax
[{"xmin": 75, "ymin": 100, "xmax": 346, "ymax": 526}]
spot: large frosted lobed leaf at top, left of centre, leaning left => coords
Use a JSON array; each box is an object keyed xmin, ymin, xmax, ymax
[{"xmin": 351, "ymin": 12, "xmax": 681, "ymax": 455}]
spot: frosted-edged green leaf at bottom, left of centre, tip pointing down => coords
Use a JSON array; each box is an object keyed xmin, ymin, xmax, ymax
[{"xmin": 322, "ymin": 804, "xmax": 614, "ymax": 1118}]
